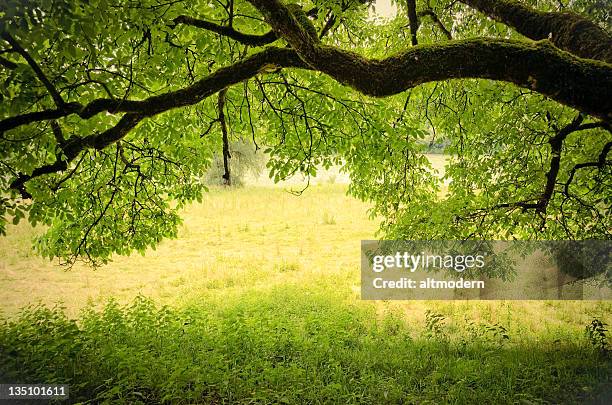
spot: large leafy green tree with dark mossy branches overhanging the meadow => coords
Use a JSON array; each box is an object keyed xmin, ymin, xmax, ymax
[{"xmin": 0, "ymin": 0, "xmax": 612, "ymax": 264}]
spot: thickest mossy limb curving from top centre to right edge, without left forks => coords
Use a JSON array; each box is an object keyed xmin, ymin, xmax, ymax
[{"xmin": 249, "ymin": 0, "xmax": 612, "ymax": 121}]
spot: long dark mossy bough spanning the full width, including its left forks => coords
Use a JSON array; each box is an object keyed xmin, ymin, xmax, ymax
[{"xmin": 0, "ymin": 0, "xmax": 612, "ymax": 198}]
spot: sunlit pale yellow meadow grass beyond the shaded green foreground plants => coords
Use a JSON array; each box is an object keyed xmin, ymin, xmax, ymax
[{"xmin": 0, "ymin": 178, "xmax": 612, "ymax": 336}]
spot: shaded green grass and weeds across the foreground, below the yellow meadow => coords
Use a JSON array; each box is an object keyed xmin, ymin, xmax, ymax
[{"xmin": 0, "ymin": 289, "xmax": 610, "ymax": 404}]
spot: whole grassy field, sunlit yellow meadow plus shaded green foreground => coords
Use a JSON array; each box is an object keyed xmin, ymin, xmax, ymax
[{"xmin": 0, "ymin": 172, "xmax": 612, "ymax": 404}]
